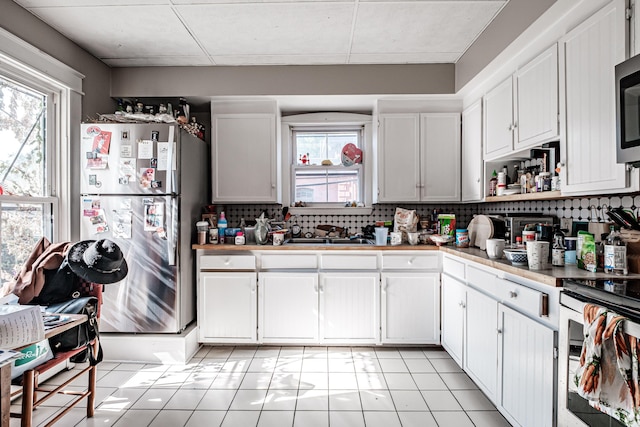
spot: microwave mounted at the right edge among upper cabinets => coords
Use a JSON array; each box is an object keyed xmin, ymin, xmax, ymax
[{"xmin": 615, "ymin": 55, "xmax": 640, "ymax": 166}]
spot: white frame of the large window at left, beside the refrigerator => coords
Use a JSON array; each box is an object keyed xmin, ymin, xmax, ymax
[{"xmin": 0, "ymin": 28, "xmax": 84, "ymax": 242}]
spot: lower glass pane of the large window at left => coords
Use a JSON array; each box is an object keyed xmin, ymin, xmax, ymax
[{"xmin": 0, "ymin": 203, "xmax": 51, "ymax": 283}]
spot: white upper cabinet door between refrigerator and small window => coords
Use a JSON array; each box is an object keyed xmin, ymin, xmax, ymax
[{"xmin": 211, "ymin": 114, "xmax": 277, "ymax": 202}]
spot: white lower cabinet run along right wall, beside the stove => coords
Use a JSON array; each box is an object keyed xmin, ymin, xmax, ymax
[{"xmin": 442, "ymin": 255, "xmax": 559, "ymax": 427}]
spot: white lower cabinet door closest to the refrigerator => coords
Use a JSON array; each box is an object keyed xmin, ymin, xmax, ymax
[{"xmin": 198, "ymin": 272, "xmax": 258, "ymax": 343}]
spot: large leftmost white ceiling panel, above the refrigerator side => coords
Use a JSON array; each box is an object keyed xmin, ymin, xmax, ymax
[{"xmin": 25, "ymin": 5, "xmax": 203, "ymax": 58}]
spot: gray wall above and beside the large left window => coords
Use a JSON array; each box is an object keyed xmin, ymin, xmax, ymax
[{"xmin": 0, "ymin": 0, "xmax": 114, "ymax": 241}]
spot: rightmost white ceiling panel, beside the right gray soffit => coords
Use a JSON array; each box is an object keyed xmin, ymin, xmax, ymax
[{"xmin": 351, "ymin": 1, "xmax": 505, "ymax": 53}]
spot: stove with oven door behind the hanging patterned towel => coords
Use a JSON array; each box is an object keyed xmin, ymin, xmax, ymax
[{"xmin": 557, "ymin": 278, "xmax": 640, "ymax": 427}]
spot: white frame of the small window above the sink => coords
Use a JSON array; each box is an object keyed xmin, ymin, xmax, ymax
[{"xmin": 282, "ymin": 113, "xmax": 374, "ymax": 215}]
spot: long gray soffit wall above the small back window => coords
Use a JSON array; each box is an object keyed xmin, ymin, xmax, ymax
[{"xmin": 111, "ymin": 64, "xmax": 454, "ymax": 97}]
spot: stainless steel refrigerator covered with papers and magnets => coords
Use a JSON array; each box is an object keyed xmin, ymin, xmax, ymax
[{"xmin": 80, "ymin": 123, "xmax": 209, "ymax": 333}]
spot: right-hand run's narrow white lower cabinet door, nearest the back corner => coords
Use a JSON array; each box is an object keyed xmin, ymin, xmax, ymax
[{"xmin": 442, "ymin": 274, "xmax": 467, "ymax": 367}]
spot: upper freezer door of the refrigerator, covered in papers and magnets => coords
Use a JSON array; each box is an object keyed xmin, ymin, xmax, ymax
[{"xmin": 80, "ymin": 123, "xmax": 180, "ymax": 194}]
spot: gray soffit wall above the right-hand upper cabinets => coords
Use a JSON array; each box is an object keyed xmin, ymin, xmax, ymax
[{"xmin": 455, "ymin": 0, "xmax": 557, "ymax": 92}]
